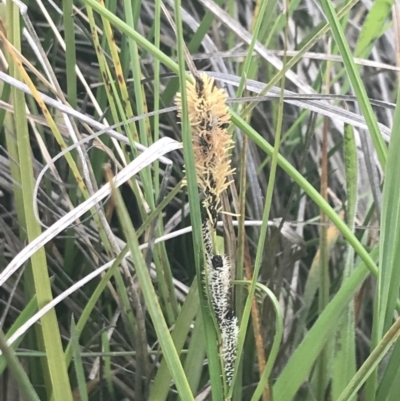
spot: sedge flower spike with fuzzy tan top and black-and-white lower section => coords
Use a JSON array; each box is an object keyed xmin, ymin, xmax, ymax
[{"xmin": 175, "ymin": 74, "xmax": 239, "ymax": 385}]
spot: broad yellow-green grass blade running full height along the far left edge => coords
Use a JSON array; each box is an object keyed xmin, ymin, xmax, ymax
[{"xmin": 4, "ymin": 2, "xmax": 72, "ymax": 401}]
